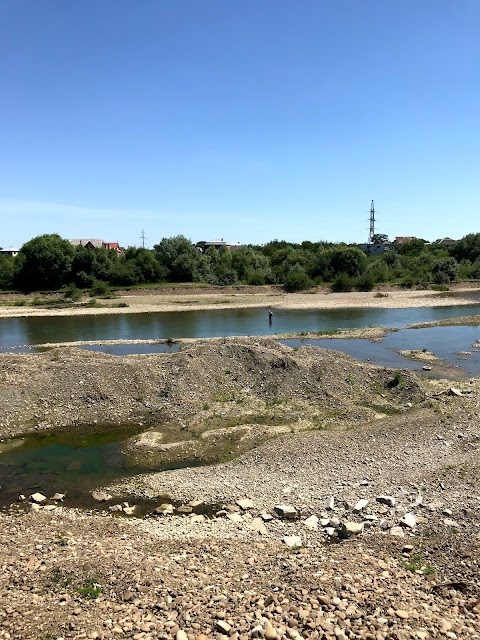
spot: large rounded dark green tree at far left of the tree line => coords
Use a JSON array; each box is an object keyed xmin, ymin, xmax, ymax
[{"xmin": 15, "ymin": 233, "xmax": 73, "ymax": 291}]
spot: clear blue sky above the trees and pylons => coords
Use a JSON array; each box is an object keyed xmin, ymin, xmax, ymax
[{"xmin": 0, "ymin": 0, "xmax": 480, "ymax": 247}]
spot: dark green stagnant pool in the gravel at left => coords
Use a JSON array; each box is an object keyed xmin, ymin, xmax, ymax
[{"xmin": 0, "ymin": 425, "xmax": 199, "ymax": 509}]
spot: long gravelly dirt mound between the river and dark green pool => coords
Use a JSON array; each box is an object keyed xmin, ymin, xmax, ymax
[{"xmin": 0, "ymin": 338, "xmax": 424, "ymax": 435}]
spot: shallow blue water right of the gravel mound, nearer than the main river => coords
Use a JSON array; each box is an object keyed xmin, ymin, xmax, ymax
[{"xmin": 281, "ymin": 325, "xmax": 480, "ymax": 377}]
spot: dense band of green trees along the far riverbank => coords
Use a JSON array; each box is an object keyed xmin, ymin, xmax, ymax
[{"xmin": 0, "ymin": 233, "xmax": 480, "ymax": 292}]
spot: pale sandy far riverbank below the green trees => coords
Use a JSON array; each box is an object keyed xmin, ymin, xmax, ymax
[{"xmin": 0, "ymin": 287, "xmax": 478, "ymax": 318}]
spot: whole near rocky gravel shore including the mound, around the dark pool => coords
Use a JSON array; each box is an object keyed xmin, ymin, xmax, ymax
[{"xmin": 0, "ymin": 338, "xmax": 480, "ymax": 640}]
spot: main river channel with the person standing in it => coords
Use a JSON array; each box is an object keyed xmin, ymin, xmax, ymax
[{"xmin": 0, "ymin": 304, "xmax": 480, "ymax": 349}]
